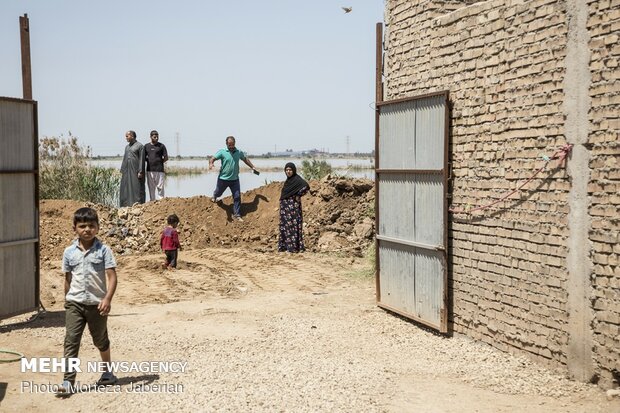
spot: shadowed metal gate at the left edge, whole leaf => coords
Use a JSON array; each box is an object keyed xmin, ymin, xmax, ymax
[{"xmin": 0, "ymin": 97, "xmax": 39, "ymax": 318}]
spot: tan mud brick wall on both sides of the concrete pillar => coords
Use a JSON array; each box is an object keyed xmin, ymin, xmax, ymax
[{"xmin": 384, "ymin": 0, "xmax": 620, "ymax": 385}]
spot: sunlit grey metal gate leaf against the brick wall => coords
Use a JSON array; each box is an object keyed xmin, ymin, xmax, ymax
[{"xmin": 375, "ymin": 92, "xmax": 449, "ymax": 332}]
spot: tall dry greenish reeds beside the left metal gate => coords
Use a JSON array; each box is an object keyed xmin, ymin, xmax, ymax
[{"xmin": 39, "ymin": 134, "xmax": 121, "ymax": 206}]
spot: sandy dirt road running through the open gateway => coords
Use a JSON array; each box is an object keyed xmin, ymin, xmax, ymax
[{"xmin": 0, "ymin": 248, "xmax": 620, "ymax": 413}]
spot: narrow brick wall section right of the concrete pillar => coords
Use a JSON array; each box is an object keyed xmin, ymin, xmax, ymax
[{"xmin": 587, "ymin": 0, "xmax": 620, "ymax": 386}]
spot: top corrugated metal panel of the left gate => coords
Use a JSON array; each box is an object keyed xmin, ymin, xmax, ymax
[{"xmin": 0, "ymin": 100, "xmax": 35, "ymax": 171}]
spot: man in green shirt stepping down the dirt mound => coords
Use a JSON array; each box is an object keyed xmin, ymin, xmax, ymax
[{"xmin": 209, "ymin": 136, "xmax": 257, "ymax": 221}]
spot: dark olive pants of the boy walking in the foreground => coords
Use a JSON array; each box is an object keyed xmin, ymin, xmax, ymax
[{"xmin": 64, "ymin": 301, "xmax": 110, "ymax": 383}]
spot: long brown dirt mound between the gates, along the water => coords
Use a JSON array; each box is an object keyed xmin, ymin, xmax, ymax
[{"xmin": 40, "ymin": 176, "xmax": 374, "ymax": 265}]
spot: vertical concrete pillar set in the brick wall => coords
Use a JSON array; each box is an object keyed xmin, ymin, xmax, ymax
[{"xmin": 562, "ymin": 0, "xmax": 594, "ymax": 381}]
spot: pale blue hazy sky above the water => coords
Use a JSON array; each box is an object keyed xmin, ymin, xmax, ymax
[{"xmin": 0, "ymin": 0, "xmax": 384, "ymax": 156}]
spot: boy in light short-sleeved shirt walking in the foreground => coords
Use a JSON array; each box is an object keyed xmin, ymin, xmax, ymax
[{"xmin": 56, "ymin": 208, "xmax": 117, "ymax": 396}]
